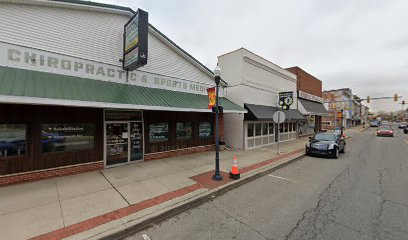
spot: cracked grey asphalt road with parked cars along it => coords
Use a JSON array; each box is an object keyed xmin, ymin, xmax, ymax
[{"xmin": 127, "ymin": 129, "xmax": 408, "ymax": 240}]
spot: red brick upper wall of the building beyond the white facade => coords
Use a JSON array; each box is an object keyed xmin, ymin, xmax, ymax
[{"xmin": 286, "ymin": 67, "xmax": 322, "ymax": 97}]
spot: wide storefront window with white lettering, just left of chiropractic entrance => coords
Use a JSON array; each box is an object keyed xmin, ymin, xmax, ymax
[{"xmin": 41, "ymin": 123, "xmax": 95, "ymax": 152}]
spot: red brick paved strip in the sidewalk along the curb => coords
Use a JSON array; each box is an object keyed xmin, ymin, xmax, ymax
[{"xmin": 31, "ymin": 148, "xmax": 304, "ymax": 240}]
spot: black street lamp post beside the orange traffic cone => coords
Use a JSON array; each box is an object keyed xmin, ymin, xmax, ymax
[{"xmin": 213, "ymin": 66, "xmax": 222, "ymax": 181}]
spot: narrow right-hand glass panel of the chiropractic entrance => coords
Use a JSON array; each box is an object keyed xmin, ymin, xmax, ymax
[{"xmin": 130, "ymin": 122, "xmax": 143, "ymax": 161}]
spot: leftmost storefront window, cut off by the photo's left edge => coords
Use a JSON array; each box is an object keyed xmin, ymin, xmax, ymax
[{"xmin": 0, "ymin": 124, "xmax": 26, "ymax": 158}]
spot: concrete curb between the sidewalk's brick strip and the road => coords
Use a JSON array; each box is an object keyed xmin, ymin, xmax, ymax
[{"xmin": 95, "ymin": 153, "xmax": 305, "ymax": 240}]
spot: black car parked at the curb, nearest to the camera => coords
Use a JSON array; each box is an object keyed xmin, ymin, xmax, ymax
[{"xmin": 306, "ymin": 132, "xmax": 346, "ymax": 158}]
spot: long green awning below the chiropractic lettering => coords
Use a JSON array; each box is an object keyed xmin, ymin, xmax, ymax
[{"xmin": 0, "ymin": 66, "xmax": 246, "ymax": 113}]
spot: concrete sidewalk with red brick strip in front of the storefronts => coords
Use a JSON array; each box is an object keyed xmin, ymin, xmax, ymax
[{"xmin": 0, "ymin": 138, "xmax": 307, "ymax": 239}]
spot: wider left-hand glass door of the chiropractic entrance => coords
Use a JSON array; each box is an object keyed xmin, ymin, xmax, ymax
[{"xmin": 106, "ymin": 123, "xmax": 129, "ymax": 166}]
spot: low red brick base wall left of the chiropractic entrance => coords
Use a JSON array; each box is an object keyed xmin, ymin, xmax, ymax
[{"xmin": 0, "ymin": 162, "xmax": 103, "ymax": 187}]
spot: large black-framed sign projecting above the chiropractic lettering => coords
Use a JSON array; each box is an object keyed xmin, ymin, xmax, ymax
[{"xmin": 123, "ymin": 9, "xmax": 149, "ymax": 71}]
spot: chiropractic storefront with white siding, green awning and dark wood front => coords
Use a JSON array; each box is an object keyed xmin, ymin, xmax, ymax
[{"xmin": 0, "ymin": 1, "xmax": 245, "ymax": 185}]
